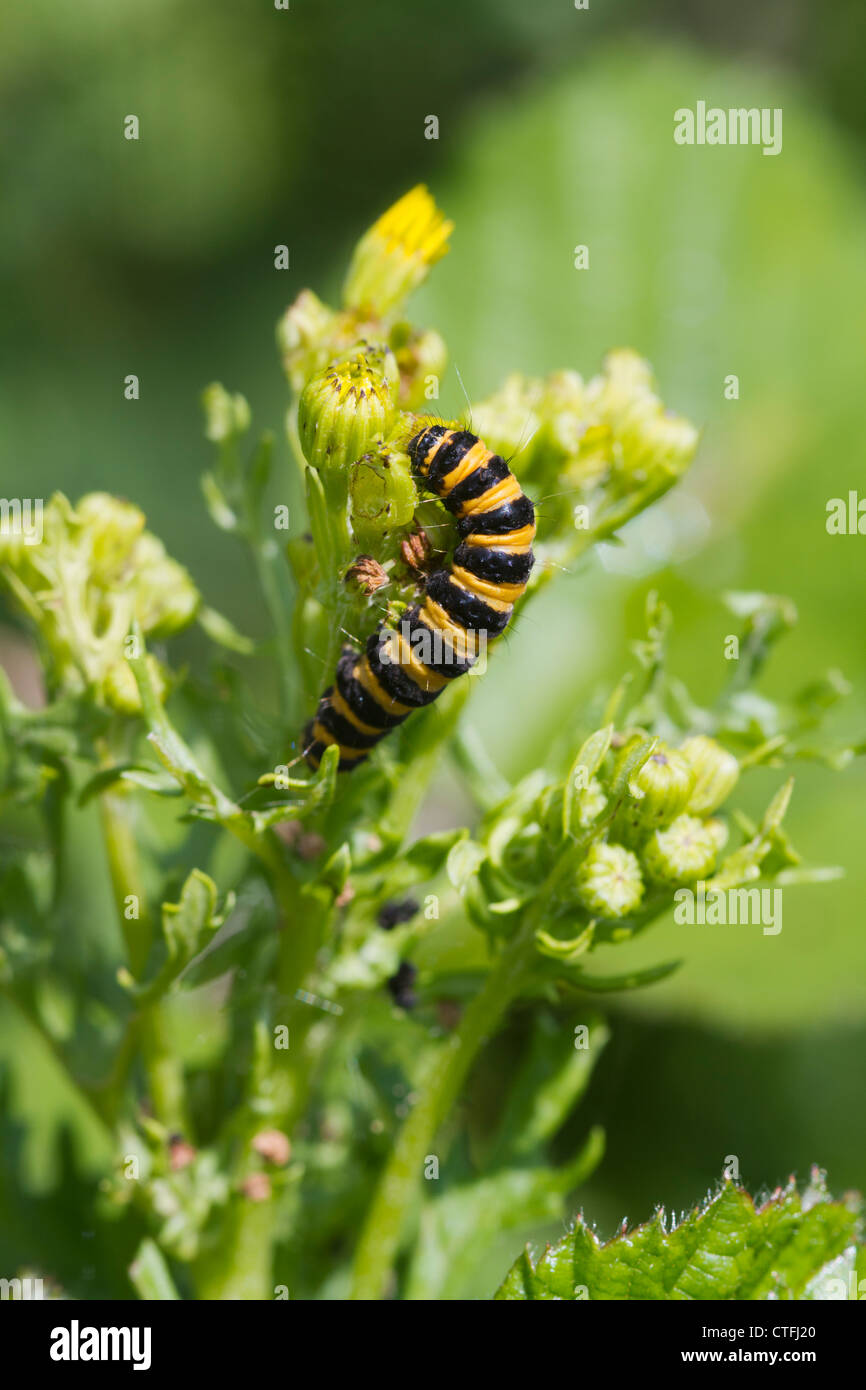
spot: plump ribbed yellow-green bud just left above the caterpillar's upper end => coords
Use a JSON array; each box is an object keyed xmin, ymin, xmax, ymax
[{"xmin": 297, "ymin": 348, "xmax": 399, "ymax": 473}]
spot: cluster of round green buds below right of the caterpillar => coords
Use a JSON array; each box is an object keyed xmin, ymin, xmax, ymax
[{"xmin": 577, "ymin": 735, "xmax": 740, "ymax": 919}]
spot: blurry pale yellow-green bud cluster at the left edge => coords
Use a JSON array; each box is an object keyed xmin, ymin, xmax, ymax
[{"xmin": 0, "ymin": 492, "xmax": 200, "ymax": 713}]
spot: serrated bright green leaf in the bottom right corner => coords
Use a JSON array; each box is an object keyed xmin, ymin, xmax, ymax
[{"xmin": 495, "ymin": 1169, "xmax": 860, "ymax": 1301}]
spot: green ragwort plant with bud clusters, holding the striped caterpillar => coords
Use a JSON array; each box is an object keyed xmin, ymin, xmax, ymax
[{"xmin": 0, "ymin": 188, "xmax": 858, "ymax": 1298}]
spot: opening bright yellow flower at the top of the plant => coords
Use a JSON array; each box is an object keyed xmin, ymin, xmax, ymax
[{"xmin": 343, "ymin": 183, "xmax": 455, "ymax": 317}]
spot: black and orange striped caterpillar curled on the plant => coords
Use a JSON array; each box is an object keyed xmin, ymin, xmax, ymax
[{"xmin": 304, "ymin": 425, "xmax": 535, "ymax": 771}]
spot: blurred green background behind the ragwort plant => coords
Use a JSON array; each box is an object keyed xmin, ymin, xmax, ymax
[{"xmin": 0, "ymin": 0, "xmax": 866, "ymax": 1282}]
